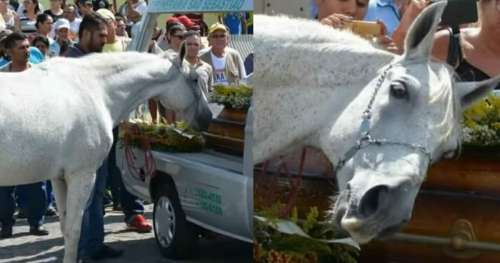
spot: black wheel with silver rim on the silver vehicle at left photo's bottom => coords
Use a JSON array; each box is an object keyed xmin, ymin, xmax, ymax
[{"xmin": 153, "ymin": 184, "xmax": 196, "ymax": 259}]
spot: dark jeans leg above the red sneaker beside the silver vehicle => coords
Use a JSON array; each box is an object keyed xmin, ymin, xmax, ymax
[{"xmin": 108, "ymin": 128, "xmax": 144, "ymax": 222}]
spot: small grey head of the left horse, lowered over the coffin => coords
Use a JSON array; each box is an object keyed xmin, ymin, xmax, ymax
[{"xmin": 159, "ymin": 45, "xmax": 212, "ymax": 130}]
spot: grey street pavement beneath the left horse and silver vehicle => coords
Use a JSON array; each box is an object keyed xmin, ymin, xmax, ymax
[{"xmin": 0, "ymin": 205, "xmax": 252, "ymax": 263}]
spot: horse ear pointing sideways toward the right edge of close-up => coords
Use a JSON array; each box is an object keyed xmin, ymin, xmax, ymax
[{"xmin": 455, "ymin": 75, "xmax": 500, "ymax": 109}]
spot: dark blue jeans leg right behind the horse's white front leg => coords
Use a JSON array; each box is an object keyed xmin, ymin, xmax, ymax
[{"xmin": 78, "ymin": 160, "xmax": 108, "ymax": 257}]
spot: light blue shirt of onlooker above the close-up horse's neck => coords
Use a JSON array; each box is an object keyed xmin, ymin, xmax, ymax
[{"xmin": 365, "ymin": 0, "xmax": 401, "ymax": 36}]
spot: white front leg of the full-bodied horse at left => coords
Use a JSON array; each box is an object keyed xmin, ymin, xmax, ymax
[{"xmin": 64, "ymin": 172, "xmax": 96, "ymax": 263}]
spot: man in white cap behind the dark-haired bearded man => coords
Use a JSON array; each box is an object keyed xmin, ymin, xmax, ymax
[{"xmin": 97, "ymin": 8, "xmax": 131, "ymax": 52}]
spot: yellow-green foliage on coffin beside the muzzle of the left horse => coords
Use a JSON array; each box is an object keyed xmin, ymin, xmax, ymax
[{"xmin": 210, "ymin": 84, "xmax": 252, "ymax": 109}]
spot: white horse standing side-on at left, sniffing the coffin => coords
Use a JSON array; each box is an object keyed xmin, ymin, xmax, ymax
[{"xmin": 0, "ymin": 52, "xmax": 211, "ymax": 263}]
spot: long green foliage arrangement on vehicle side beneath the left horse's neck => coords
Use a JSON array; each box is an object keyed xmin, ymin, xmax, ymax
[{"xmin": 120, "ymin": 119, "xmax": 205, "ymax": 152}]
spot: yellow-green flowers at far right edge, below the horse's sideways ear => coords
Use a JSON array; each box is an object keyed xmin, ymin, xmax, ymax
[{"xmin": 462, "ymin": 95, "xmax": 500, "ymax": 147}]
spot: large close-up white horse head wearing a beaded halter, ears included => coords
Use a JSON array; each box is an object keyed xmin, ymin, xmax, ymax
[{"xmin": 333, "ymin": 1, "xmax": 500, "ymax": 243}]
